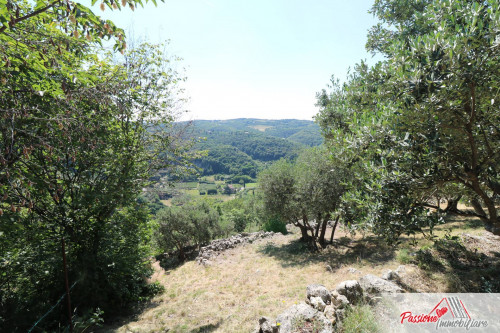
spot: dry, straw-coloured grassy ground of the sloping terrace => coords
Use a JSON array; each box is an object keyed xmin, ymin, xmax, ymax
[{"xmin": 102, "ymin": 214, "xmax": 500, "ymax": 333}]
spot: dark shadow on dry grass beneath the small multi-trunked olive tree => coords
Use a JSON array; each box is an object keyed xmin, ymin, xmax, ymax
[{"xmin": 258, "ymin": 232, "xmax": 395, "ymax": 269}]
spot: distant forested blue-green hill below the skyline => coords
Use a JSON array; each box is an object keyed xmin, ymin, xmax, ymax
[{"xmin": 182, "ymin": 118, "xmax": 323, "ymax": 177}]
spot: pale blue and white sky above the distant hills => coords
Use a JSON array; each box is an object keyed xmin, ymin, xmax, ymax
[{"xmin": 82, "ymin": 0, "xmax": 376, "ymax": 120}]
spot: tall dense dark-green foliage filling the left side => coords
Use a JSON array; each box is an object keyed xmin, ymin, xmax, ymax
[{"xmin": 0, "ymin": 1, "xmax": 192, "ymax": 332}]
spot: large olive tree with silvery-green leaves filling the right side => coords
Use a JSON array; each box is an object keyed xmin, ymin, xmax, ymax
[{"xmin": 318, "ymin": 0, "xmax": 500, "ymax": 240}]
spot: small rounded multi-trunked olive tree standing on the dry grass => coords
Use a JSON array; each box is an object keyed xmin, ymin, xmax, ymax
[{"xmin": 259, "ymin": 148, "xmax": 344, "ymax": 246}]
